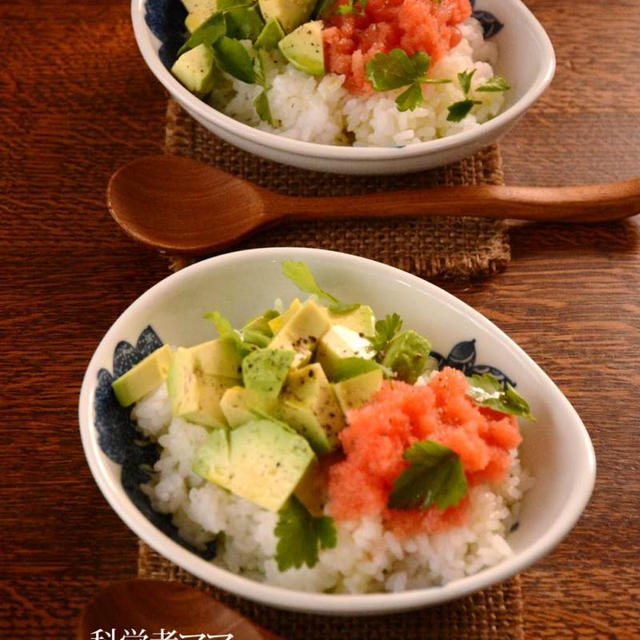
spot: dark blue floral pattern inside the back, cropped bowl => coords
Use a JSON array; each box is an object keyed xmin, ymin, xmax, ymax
[{"xmin": 145, "ymin": 0, "xmax": 504, "ymax": 69}]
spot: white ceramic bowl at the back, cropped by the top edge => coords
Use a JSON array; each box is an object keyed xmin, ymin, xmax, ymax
[{"xmin": 131, "ymin": 0, "xmax": 555, "ymax": 174}]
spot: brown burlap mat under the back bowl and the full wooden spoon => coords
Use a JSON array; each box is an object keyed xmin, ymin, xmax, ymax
[{"xmin": 165, "ymin": 101, "xmax": 510, "ymax": 279}]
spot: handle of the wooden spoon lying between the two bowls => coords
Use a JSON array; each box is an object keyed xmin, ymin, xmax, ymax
[{"xmin": 278, "ymin": 178, "xmax": 640, "ymax": 222}]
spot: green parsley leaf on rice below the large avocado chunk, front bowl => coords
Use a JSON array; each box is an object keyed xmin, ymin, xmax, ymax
[{"xmin": 274, "ymin": 497, "xmax": 338, "ymax": 571}]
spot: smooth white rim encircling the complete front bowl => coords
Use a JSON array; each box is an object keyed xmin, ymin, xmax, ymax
[{"xmin": 78, "ymin": 247, "xmax": 596, "ymax": 615}]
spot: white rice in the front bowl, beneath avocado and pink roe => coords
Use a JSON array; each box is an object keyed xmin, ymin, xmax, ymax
[{"xmin": 132, "ymin": 384, "xmax": 531, "ymax": 593}]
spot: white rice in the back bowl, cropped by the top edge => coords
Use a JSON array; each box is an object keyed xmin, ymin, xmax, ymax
[{"xmin": 214, "ymin": 18, "xmax": 504, "ymax": 146}]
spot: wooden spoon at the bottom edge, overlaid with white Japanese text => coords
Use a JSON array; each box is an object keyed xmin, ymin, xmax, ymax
[{"xmin": 76, "ymin": 579, "xmax": 283, "ymax": 640}]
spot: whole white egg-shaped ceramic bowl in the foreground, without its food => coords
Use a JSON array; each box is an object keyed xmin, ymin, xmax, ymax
[{"xmin": 79, "ymin": 248, "xmax": 595, "ymax": 615}]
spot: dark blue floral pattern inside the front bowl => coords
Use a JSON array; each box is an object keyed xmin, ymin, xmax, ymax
[{"xmin": 94, "ymin": 326, "xmax": 515, "ymax": 560}]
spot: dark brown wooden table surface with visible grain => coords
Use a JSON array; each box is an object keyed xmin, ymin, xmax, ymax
[{"xmin": 0, "ymin": 0, "xmax": 640, "ymax": 640}]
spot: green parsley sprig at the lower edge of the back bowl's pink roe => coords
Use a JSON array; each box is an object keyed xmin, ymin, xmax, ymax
[{"xmin": 365, "ymin": 49, "xmax": 451, "ymax": 111}]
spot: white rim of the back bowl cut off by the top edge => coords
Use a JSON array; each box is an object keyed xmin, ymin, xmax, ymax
[{"xmin": 131, "ymin": 0, "xmax": 556, "ymax": 161}]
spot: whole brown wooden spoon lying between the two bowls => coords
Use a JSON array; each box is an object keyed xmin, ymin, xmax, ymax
[{"xmin": 107, "ymin": 156, "xmax": 640, "ymax": 255}]
